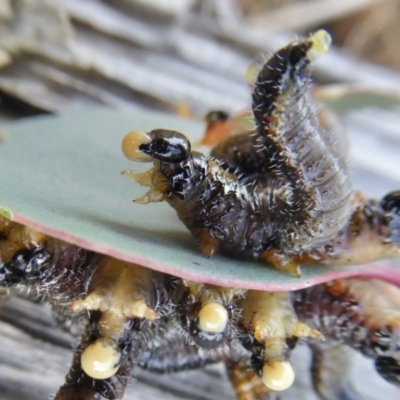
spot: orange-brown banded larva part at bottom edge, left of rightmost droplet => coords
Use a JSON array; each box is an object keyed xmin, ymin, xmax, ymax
[{"xmin": 226, "ymin": 361, "xmax": 277, "ymax": 400}]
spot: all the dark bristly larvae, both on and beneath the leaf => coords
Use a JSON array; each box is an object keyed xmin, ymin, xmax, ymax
[{"xmin": 0, "ymin": 31, "xmax": 400, "ymax": 400}]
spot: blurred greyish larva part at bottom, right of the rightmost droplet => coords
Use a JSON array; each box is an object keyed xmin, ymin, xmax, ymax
[{"xmin": 310, "ymin": 343, "xmax": 362, "ymax": 400}]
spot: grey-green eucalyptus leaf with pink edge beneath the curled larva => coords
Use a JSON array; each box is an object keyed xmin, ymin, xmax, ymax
[{"xmin": 0, "ymin": 109, "xmax": 400, "ymax": 290}]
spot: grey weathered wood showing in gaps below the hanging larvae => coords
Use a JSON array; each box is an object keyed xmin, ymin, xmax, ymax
[{"xmin": 0, "ymin": 297, "xmax": 399, "ymax": 400}]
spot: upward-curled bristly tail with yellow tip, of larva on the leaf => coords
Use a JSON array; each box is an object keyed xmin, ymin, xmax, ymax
[{"xmin": 252, "ymin": 31, "xmax": 351, "ymax": 252}]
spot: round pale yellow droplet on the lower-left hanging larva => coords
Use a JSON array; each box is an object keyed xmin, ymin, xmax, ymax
[{"xmin": 81, "ymin": 338, "xmax": 121, "ymax": 379}]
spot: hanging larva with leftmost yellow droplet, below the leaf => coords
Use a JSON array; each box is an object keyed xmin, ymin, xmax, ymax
[{"xmin": 56, "ymin": 257, "xmax": 165, "ymax": 400}]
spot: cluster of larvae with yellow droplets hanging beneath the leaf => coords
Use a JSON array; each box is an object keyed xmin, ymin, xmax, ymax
[{"xmin": 0, "ymin": 217, "xmax": 400, "ymax": 400}]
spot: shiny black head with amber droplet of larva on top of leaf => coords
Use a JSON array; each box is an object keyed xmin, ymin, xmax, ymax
[{"xmin": 122, "ymin": 129, "xmax": 190, "ymax": 163}]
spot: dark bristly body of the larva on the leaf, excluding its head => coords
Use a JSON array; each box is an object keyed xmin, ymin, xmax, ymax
[{"xmin": 162, "ymin": 33, "xmax": 351, "ymax": 258}]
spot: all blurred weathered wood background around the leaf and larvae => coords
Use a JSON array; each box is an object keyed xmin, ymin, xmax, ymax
[{"xmin": 0, "ymin": 0, "xmax": 400, "ymax": 400}]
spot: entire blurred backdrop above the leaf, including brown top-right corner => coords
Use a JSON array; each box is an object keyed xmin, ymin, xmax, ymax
[{"xmin": 0, "ymin": 0, "xmax": 400, "ymax": 117}]
